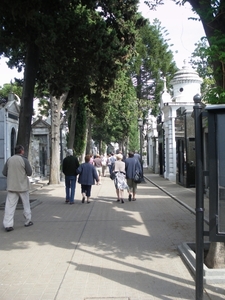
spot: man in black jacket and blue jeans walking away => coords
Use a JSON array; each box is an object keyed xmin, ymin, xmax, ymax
[{"xmin": 62, "ymin": 149, "xmax": 80, "ymax": 204}]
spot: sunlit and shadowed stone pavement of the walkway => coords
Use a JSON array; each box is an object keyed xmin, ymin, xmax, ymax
[{"xmin": 0, "ymin": 172, "xmax": 225, "ymax": 300}]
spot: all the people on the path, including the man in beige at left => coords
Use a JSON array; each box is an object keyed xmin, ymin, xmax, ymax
[{"xmin": 2, "ymin": 145, "xmax": 143, "ymax": 232}]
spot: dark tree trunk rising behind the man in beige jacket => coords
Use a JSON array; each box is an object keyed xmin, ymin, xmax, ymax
[{"xmin": 17, "ymin": 42, "xmax": 38, "ymax": 157}]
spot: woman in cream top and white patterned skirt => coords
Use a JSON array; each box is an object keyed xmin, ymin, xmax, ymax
[{"xmin": 114, "ymin": 154, "xmax": 128, "ymax": 203}]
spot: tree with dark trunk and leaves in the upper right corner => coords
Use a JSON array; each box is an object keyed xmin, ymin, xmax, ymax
[{"xmin": 145, "ymin": 0, "xmax": 225, "ymax": 103}]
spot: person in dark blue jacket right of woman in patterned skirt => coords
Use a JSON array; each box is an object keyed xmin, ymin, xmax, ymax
[{"xmin": 125, "ymin": 152, "xmax": 142, "ymax": 201}]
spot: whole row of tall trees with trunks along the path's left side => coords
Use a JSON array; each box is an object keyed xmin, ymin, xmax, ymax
[{"xmin": 0, "ymin": 0, "xmax": 176, "ymax": 183}]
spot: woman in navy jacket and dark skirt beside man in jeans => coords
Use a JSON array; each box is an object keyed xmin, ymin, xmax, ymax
[{"xmin": 77, "ymin": 155, "xmax": 99, "ymax": 203}]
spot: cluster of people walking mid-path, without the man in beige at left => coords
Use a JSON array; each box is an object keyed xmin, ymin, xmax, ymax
[{"xmin": 62, "ymin": 149, "xmax": 143, "ymax": 204}]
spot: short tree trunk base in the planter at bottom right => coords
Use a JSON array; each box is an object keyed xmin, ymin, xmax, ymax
[{"xmin": 205, "ymin": 242, "xmax": 225, "ymax": 269}]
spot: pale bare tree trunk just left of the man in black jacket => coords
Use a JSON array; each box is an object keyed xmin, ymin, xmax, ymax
[{"xmin": 49, "ymin": 93, "xmax": 68, "ymax": 184}]
